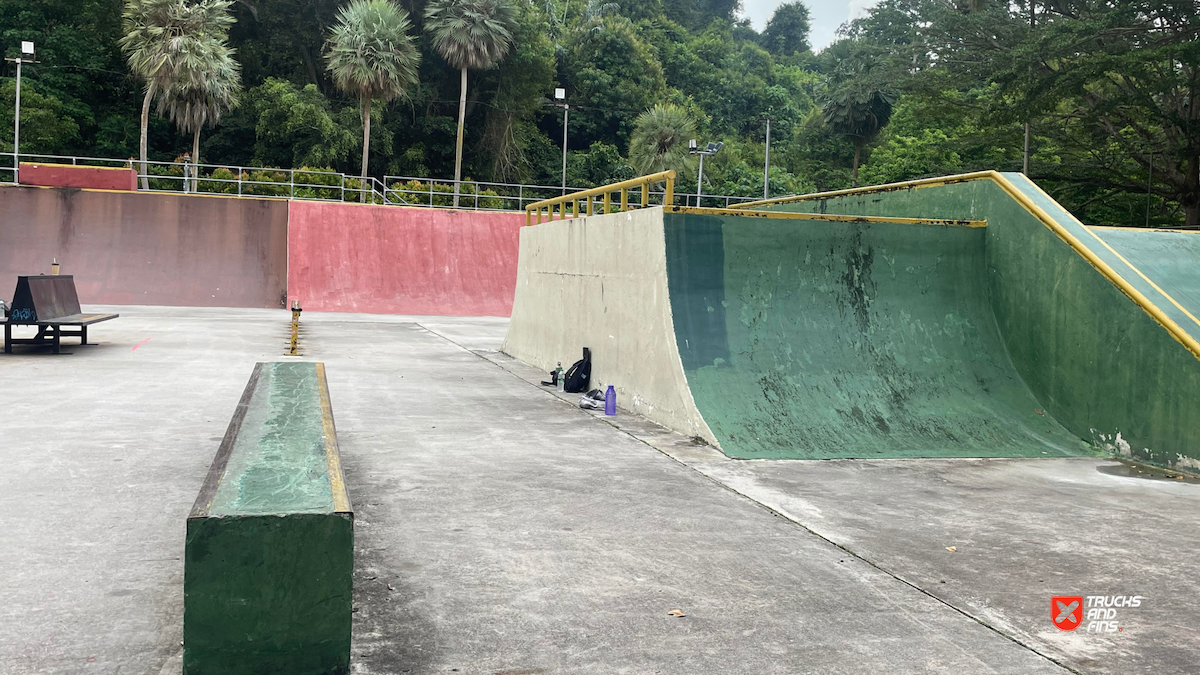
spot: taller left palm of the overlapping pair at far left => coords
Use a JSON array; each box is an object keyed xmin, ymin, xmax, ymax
[{"xmin": 119, "ymin": 0, "xmax": 234, "ymax": 190}]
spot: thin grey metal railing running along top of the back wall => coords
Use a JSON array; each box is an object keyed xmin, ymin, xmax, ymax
[{"xmin": 0, "ymin": 153, "xmax": 756, "ymax": 211}]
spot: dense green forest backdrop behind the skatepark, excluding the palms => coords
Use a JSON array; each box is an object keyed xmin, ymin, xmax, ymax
[{"xmin": 0, "ymin": 0, "xmax": 1200, "ymax": 226}]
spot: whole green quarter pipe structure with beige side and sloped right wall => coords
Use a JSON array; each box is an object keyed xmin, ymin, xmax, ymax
[{"xmin": 504, "ymin": 172, "xmax": 1200, "ymax": 470}]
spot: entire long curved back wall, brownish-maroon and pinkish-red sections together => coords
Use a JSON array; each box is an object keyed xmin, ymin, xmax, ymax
[{"xmin": 0, "ymin": 186, "xmax": 524, "ymax": 316}]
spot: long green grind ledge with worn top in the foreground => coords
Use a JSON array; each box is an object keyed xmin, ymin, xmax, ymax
[{"xmin": 184, "ymin": 363, "xmax": 354, "ymax": 675}]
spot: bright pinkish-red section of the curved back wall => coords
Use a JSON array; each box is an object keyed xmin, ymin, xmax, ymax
[{"xmin": 288, "ymin": 202, "xmax": 524, "ymax": 316}]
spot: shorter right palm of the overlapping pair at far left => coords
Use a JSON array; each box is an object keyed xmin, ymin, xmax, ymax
[{"xmin": 158, "ymin": 43, "xmax": 241, "ymax": 191}]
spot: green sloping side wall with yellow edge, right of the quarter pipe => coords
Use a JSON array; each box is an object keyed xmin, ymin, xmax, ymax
[{"xmin": 748, "ymin": 173, "xmax": 1200, "ymax": 471}]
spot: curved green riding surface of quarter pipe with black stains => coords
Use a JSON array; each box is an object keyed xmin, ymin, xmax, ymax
[{"xmin": 664, "ymin": 214, "xmax": 1088, "ymax": 458}]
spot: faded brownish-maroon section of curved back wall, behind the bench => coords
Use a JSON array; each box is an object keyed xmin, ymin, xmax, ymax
[{"xmin": 0, "ymin": 186, "xmax": 288, "ymax": 307}]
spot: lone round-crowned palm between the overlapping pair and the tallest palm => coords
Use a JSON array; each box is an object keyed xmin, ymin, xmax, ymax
[{"xmin": 325, "ymin": 0, "xmax": 421, "ymax": 202}]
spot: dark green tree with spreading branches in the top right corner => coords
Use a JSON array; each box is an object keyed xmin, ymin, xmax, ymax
[{"xmin": 932, "ymin": 0, "xmax": 1200, "ymax": 227}]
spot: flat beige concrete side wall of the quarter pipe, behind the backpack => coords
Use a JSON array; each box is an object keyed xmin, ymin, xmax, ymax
[{"xmin": 503, "ymin": 208, "xmax": 716, "ymax": 444}]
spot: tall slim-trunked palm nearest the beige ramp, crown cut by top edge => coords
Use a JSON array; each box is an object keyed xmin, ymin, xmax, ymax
[{"xmin": 425, "ymin": 0, "xmax": 516, "ymax": 207}]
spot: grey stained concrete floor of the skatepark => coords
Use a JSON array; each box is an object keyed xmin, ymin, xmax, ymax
[{"xmin": 0, "ymin": 306, "xmax": 1200, "ymax": 675}]
